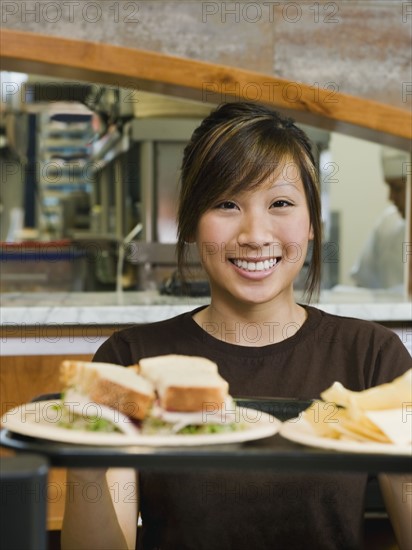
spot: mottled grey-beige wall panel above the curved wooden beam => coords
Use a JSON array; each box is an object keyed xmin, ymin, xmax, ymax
[{"xmin": 1, "ymin": 0, "xmax": 412, "ymax": 108}]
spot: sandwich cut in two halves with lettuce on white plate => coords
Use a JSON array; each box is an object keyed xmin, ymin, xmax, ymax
[{"xmin": 56, "ymin": 355, "xmax": 242, "ymax": 434}]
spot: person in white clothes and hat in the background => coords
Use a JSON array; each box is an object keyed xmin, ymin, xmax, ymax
[{"xmin": 351, "ymin": 147, "xmax": 410, "ymax": 291}]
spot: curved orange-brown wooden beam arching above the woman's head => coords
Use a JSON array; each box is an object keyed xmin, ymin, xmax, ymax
[{"xmin": 0, "ymin": 29, "xmax": 412, "ymax": 150}]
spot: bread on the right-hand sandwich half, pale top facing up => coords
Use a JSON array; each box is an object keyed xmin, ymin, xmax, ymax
[{"xmin": 139, "ymin": 354, "xmax": 229, "ymax": 412}]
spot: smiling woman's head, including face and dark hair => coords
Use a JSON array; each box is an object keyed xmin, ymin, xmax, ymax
[{"xmin": 177, "ymin": 103, "xmax": 321, "ymax": 308}]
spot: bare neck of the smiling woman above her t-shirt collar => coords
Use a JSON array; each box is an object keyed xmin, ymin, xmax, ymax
[{"xmin": 194, "ymin": 299, "xmax": 307, "ymax": 347}]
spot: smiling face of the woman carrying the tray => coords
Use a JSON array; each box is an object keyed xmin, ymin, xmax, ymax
[{"xmin": 196, "ymin": 162, "xmax": 313, "ymax": 306}]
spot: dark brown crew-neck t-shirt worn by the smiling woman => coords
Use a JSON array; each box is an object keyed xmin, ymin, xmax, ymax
[{"xmin": 94, "ymin": 307, "xmax": 412, "ymax": 550}]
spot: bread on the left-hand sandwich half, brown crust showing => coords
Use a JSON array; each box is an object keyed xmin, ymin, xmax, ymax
[{"xmin": 60, "ymin": 361, "xmax": 155, "ymax": 420}]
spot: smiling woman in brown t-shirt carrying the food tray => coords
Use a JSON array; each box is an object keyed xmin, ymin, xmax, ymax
[{"xmin": 61, "ymin": 102, "xmax": 412, "ymax": 550}]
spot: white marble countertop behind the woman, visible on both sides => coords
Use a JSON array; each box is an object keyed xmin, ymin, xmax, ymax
[{"xmin": 0, "ymin": 287, "xmax": 412, "ymax": 326}]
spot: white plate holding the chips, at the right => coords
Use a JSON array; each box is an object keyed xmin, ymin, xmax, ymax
[{"xmin": 279, "ymin": 417, "xmax": 412, "ymax": 456}]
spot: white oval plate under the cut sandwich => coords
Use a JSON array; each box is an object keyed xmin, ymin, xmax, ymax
[{"xmin": 1, "ymin": 400, "xmax": 281, "ymax": 447}]
